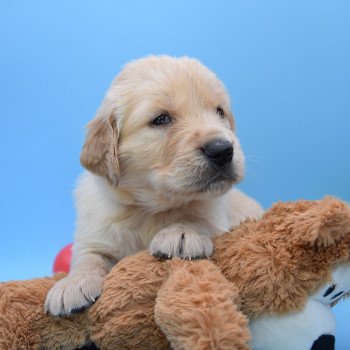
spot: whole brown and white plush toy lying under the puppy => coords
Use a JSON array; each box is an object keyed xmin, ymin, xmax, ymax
[{"xmin": 0, "ymin": 197, "xmax": 350, "ymax": 350}]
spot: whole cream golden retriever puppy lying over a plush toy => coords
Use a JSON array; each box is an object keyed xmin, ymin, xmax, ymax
[{"xmin": 45, "ymin": 56, "xmax": 263, "ymax": 316}]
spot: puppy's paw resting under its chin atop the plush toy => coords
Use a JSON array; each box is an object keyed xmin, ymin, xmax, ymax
[{"xmin": 149, "ymin": 224, "xmax": 213, "ymax": 260}]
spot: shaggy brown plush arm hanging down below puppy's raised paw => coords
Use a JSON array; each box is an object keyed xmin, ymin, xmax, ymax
[{"xmin": 155, "ymin": 260, "xmax": 249, "ymax": 350}]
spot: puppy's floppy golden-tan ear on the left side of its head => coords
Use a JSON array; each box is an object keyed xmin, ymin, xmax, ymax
[{"xmin": 80, "ymin": 113, "xmax": 119, "ymax": 186}]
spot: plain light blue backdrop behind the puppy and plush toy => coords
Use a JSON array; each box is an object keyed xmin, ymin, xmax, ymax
[{"xmin": 0, "ymin": 0, "xmax": 350, "ymax": 350}]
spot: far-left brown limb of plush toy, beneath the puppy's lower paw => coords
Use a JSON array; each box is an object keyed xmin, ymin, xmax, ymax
[{"xmin": 0, "ymin": 274, "xmax": 88, "ymax": 350}]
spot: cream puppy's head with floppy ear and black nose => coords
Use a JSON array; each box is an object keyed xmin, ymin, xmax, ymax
[{"xmin": 81, "ymin": 56, "xmax": 244, "ymax": 205}]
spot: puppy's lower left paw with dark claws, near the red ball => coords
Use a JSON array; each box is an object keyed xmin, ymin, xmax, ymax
[{"xmin": 45, "ymin": 274, "xmax": 104, "ymax": 317}]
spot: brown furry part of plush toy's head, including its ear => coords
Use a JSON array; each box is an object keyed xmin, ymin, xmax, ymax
[{"xmin": 212, "ymin": 197, "xmax": 350, "ymax": 317}]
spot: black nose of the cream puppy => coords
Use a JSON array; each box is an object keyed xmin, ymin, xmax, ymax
[{"xmin": 201, "ymin": 139, "xmax": 233, "ymax": 166}]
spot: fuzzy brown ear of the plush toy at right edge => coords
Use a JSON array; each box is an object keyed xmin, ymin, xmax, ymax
[{"xmin": 292, "ymin": 196, "xmax": 350, "ymax": 247}]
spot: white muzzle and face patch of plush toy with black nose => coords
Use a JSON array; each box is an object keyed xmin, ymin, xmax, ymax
[{"xmin": 249, "ymin": 264, "xmax": 350, "ymax": 350}]
